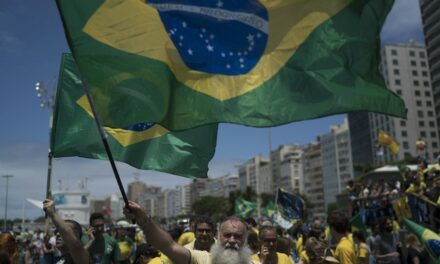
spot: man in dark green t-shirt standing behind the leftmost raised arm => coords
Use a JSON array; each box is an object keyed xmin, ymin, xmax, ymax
[{"xmin": 85, "ymin": 213, "xmax": 121, "ymax": 264}]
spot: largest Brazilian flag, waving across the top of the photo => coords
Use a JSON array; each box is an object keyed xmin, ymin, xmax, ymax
[{"xmin": 57, "ymin": 0, "xmax": 406, "ymax": 130}]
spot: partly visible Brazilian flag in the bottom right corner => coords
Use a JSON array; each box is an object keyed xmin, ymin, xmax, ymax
[{"xmin": 403, "ymin": 218, "xmax": 440, "ymax": 263}]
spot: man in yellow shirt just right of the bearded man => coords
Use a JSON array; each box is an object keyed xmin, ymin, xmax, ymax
[{"xmin": 252, "ymin": 226, "xmax": 293, "ymax": 264}]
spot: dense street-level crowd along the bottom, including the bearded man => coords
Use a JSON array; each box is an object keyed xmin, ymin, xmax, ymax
[{"xmin": 0, "ymin": 193, "xmax": 436, "ymax": 264}]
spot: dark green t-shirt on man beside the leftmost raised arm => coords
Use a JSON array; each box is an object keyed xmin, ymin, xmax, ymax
[{"xmin": 88, "ymin": 233, "xmax": 121, "ymax": 264}]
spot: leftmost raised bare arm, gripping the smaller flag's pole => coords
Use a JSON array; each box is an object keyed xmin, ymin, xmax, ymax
[{"xmin": 43, "ymin": 199, "xmax": 89, "ymax": 264}]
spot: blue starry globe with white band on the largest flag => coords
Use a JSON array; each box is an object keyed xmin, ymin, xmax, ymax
[{"xmin": 147, "ymin": 0, "xmax": 269, "ymax": 75}]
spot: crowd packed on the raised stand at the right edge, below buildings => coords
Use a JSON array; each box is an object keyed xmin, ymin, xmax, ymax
[{"xmin": 346, "ymin": 159, "xmax": 440, "ymax": 230}]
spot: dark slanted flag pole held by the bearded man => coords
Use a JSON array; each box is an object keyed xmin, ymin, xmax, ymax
[{"xmin": 81, "ymin": 82, "xmax": 128, "ymax": 207}]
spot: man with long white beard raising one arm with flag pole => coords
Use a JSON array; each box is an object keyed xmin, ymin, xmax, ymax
[{"xmin": 124, "ymin": 201, "xmax": 259, "ymax": 264}]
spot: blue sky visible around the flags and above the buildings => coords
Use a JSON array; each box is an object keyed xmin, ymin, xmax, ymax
[{"xmin": 0, "ymin": 0, "xmax": 423, "ymax": 218}]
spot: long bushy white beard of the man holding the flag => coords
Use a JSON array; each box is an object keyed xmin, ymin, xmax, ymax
[{"xmin": 210, "ymin": 242, "xmax": 252, "ymax": 264}]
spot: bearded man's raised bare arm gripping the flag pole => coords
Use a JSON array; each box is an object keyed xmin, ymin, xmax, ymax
[{"xmin": 124, "ymin": 201, "xmax": 191, "ymax": 264}]
